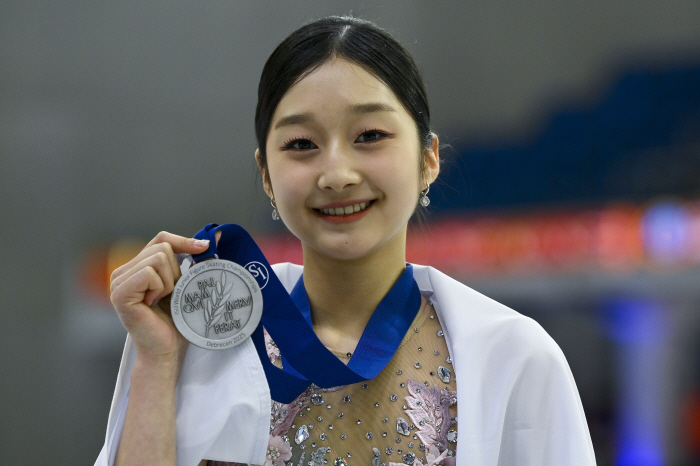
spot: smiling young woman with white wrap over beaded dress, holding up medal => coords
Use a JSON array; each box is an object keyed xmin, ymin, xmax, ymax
[{"xmin": 98, "ymin": 17, "xmax": 595, "ymax": 466}]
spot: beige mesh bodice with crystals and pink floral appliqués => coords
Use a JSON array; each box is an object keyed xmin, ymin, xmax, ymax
[{"xmin": 210, "ymin": 302, "xmax": 457, "ymax": 466}]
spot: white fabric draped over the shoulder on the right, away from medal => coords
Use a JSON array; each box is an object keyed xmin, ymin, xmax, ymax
[{"xmin": 414, "ymin": 266, "xmax": 595, "ymax": 466}]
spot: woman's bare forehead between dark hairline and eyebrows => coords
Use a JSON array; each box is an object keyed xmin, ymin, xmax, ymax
[{"xmin": 273, "ymin": 59, "xmax": 408, "ymax": 120}]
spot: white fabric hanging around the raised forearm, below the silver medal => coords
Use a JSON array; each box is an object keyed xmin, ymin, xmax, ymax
[{"xmin": 95, "ymin": 324, "xmax": 270, "ymax": 466}]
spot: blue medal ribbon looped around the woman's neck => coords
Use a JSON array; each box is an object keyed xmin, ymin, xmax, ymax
[{"xmin": 192, "ymin": 223, "xmax": 421, "ymax": 404}]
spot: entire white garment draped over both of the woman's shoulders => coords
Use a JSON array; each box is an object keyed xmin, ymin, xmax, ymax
[{"xmin": 95, "ymin": 264, "xmax": 595, "ymax": 466}]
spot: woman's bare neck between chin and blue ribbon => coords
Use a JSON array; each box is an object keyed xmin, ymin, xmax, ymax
[{"xmin": 302, "ymin": 229, "xmax": 406, "ymax": 353}]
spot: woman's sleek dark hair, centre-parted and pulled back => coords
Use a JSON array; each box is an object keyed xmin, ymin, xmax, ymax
[{"xmin": 255, "ymin": 16, "xmax": 432, "ymax": 177}]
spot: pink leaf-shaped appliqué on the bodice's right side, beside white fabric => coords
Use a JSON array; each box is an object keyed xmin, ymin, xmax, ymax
[{"xmin": 406, "ymin": 379, "xmax": 457, "ymax": 451}]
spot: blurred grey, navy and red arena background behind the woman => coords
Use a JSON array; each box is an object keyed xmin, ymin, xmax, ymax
[{"xmin": 0, "ymin": 0, "xmax": 700, "ymax": 466}]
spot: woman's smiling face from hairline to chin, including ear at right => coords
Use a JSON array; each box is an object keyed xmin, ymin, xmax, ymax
[{"xmin": 263, "ymin": 59, "xmax": 438, "ymax": 260}]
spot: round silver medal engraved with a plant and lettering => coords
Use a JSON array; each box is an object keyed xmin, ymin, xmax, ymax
[{"xmin": 170, "ymin": 259, "xmax": 263, "ymax": 350}]
